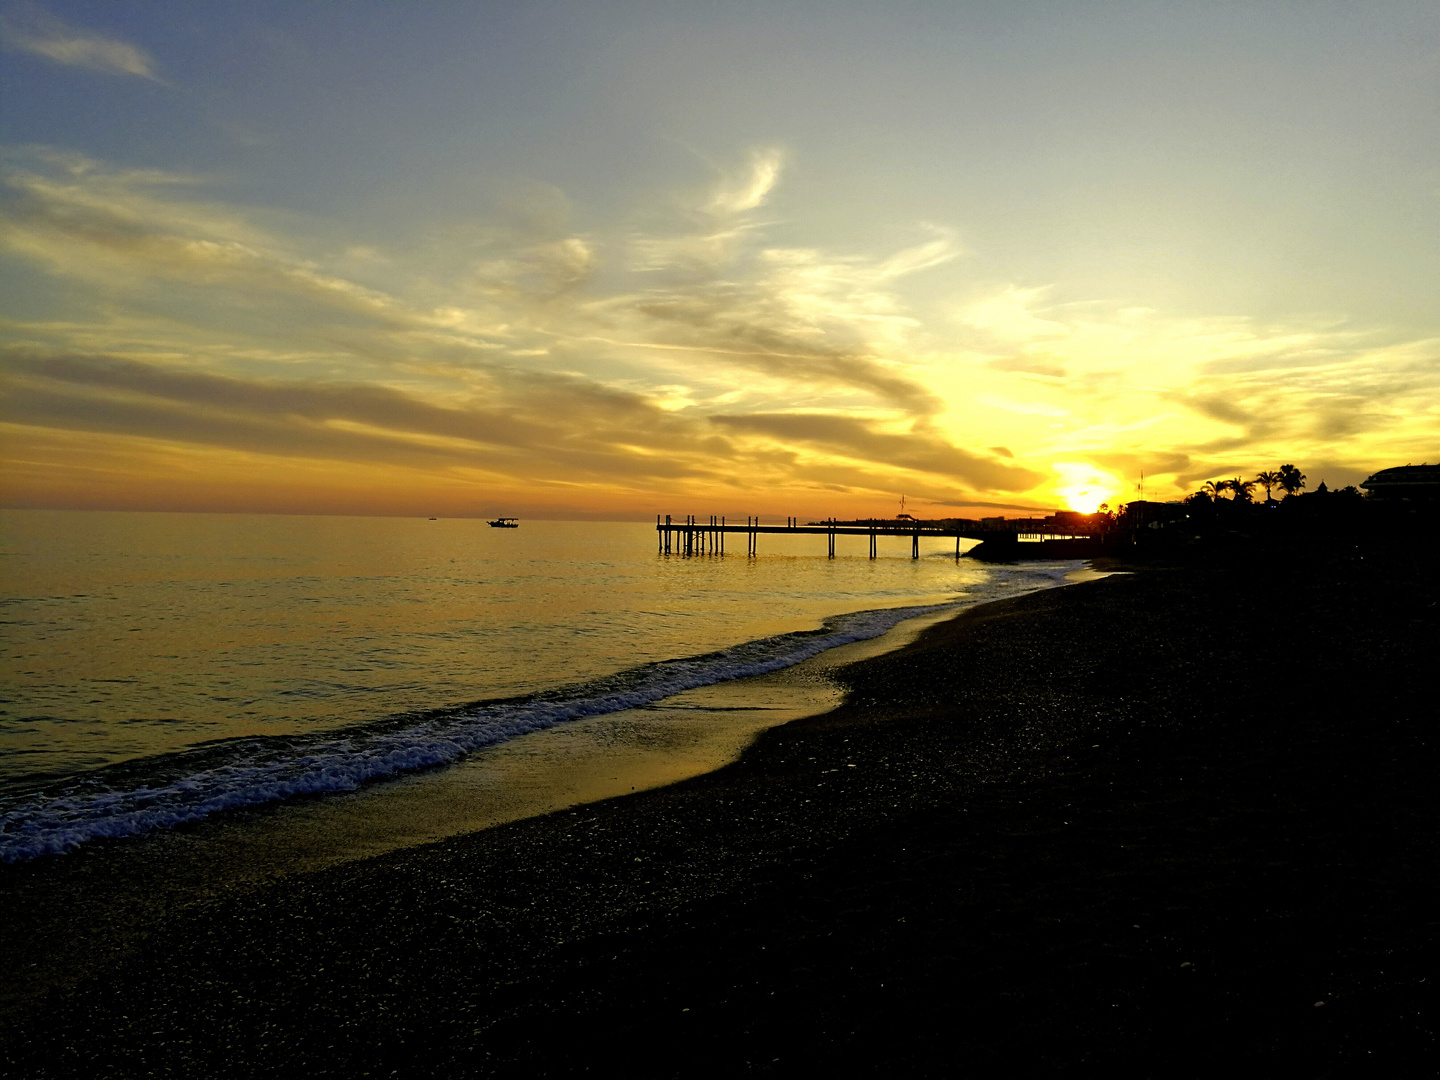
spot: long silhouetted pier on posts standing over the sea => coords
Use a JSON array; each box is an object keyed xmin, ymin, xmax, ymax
[{"xmin": 655, "ymin": 510, "xmax": 1100, "ymax": 559}]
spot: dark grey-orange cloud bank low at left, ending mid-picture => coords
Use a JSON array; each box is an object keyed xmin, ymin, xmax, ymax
[{"xmin": 0, "ymin": 348, "xmax": 704, "ymax": 481}]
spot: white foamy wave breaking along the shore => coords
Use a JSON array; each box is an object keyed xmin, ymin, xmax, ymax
[{"xmin": 0, "ymin": 564, "xmax": 1071, "ymax": 863}]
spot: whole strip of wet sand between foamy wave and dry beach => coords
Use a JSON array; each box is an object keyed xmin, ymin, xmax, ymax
[{"xmin": 0, "ymin": 570, "xmax": 1089, "ymax": 1020}]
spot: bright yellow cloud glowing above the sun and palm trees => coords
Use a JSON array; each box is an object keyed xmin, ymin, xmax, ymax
[{"xmin": 959, "ymin": 285, "xmax": 1440, "ymax": 494}]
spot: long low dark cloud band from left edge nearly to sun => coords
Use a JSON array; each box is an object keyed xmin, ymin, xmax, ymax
[{"xmin": 0, "ymin": 346, "xmax": 1041, "ymax": 515}]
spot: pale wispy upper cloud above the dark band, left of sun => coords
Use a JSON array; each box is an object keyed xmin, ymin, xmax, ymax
[{"xmin": 0, "ymin": 151, "xmax": 953, "ymax": 416}]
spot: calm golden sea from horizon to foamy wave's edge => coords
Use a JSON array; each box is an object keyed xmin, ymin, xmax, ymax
[{"xmin": 0, "ymin": 511, "xmax": 1073, "ymax": 860}]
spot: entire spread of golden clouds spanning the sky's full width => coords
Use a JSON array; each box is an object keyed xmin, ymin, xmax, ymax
[{"xmin": 0, "ymin": 150, "xmax": 1440, "ymax": 513}]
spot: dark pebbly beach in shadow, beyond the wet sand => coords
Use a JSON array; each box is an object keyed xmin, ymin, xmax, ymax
[{"xmin": 4, "ymin": 541, "xmax": 1440, "ymax": 1077}]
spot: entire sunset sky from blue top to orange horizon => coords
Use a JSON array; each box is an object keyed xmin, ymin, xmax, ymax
[{"xmin": 0, "ymin": 0, "xmax": 1440, "ymax": 518}]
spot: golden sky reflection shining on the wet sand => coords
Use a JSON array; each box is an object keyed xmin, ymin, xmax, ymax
[{"xmin": 185, "ymin": 612, "xmax": 953, "ymax": 877}]
